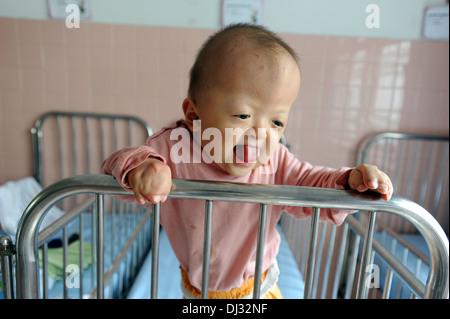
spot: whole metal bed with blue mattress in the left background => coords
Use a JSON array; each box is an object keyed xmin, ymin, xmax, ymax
[{"xmin": 0, "ymin": 111, "xmax": 153, "ymax": 298}]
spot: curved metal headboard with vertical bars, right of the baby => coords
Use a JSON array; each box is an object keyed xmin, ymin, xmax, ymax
[{"xmin": 357, "ymin": 132, "xmax": 449, "ymax": 236}]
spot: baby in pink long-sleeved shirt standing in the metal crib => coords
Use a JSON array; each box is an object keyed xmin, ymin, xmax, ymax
[{"xmin": 102, "ymin": 24, "xmax": 393, "ymax": 298}]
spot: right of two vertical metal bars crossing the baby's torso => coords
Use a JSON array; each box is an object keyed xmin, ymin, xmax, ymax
[{"xmin": 253, "ymin": 204, "xmax": 267, "ymax": 299}]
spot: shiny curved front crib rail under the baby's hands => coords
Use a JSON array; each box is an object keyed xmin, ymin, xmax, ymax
[{"xmin": 16, "ymin": 175, "xmax": 449, "ymax": 298}]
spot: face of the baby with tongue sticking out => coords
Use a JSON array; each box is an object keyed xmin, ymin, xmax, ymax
[{"xmin": 189, "ymin": 49, "xmax": 300, "ymax": 176}]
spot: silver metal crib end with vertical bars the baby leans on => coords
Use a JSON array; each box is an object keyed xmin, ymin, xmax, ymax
[{"xmin": 2, "ymin": 175, "xmax": 449, "ymax": 298}]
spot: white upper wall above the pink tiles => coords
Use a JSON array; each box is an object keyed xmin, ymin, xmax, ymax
[{"xmin": 0, "ymin": 0, "xmax": 447, "ymax": 39}]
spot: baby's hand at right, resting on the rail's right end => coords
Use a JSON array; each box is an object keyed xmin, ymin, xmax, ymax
[{"xmin": 348, "ymin": 164, "xmax": 394, "ymax": 201}]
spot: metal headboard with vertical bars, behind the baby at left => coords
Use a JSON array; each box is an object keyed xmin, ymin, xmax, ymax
[{"xmin": 31, "ymin": 111, "xmax": 153, "ymax": 186}]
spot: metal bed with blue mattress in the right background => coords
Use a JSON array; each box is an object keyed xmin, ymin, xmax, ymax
[{"xmin": 350, "ymin": 132, "xmax": 449, "ymax": 298}]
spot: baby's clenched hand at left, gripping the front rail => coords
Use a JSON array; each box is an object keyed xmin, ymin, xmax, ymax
[{"xmin": 128, "ymin": 157, "xmax": 172, "ymax": 204}]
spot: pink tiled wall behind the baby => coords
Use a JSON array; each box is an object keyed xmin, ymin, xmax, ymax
[{"xmin": 0, "ymin": 18, "xmax": 449, "ymax": 184}]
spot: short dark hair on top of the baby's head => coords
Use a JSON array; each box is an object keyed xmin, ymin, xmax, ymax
[{"xmin": 188, "ymin": 23, "xmax": 298, "ymax": 101}]
